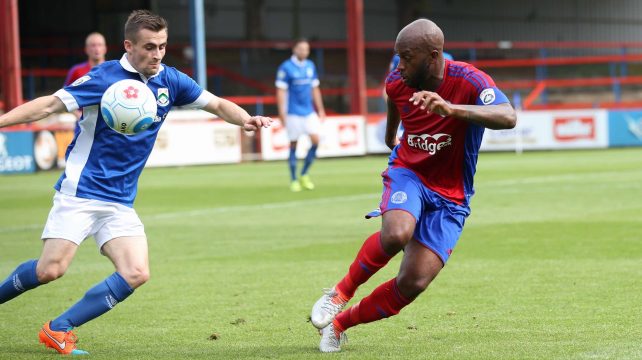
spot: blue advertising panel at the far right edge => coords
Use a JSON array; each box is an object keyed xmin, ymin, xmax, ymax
[{"xmin": 609, "ymin": 110, "xmax": 642, "ymax": 147}]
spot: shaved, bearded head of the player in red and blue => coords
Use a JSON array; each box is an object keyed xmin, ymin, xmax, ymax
[{"xmin": 395, "ymin": 19, "xmax": 445, "ymax": 89}]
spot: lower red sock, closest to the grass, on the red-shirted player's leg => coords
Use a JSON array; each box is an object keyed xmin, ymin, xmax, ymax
[{"xmin": 334, "ymin": 278, "xmax": 414, "ymax": 331}]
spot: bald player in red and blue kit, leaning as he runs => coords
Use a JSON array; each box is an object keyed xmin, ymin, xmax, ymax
[{"xmin": 310, "ymin": 19, "xmax": 516, "ymax": 352}]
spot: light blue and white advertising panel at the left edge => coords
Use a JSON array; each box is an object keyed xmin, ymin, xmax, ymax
[{"xmin": 0, "ymin": 131, "xmax": 36, "ymax": 174}]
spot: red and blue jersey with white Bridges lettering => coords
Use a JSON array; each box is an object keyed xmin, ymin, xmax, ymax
[{"xmin": 386, "ymin": 60, "xmax": 508, "ymax": 205}]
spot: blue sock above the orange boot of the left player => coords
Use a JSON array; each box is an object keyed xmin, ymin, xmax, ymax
[{"xmin": 49, "ymin": 272, "xmax": 134, "ymax": 331}]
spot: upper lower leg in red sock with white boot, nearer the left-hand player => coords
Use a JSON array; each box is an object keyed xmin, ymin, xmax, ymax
[{"xmin": 310, "ymin": 231, "xmax": 392, "ymax": 329}]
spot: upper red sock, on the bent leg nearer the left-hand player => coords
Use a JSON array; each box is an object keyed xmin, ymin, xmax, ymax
[{"xmin": 336, "ymin": 231, "xmax": 392, "ymax": 301}]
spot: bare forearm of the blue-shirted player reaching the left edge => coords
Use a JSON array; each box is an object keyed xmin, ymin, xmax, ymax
[{"xmin": 0, "ymin": 95, "xmax": 67, "ymax": 128}]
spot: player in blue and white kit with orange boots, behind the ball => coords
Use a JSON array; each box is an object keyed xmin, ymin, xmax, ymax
[{"xmin": 0, "ymin": 10, "xmax": 272, "ymax": 354}]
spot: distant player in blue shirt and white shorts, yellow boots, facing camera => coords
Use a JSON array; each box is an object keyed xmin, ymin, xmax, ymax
[{"xmin": 275, "ymin": 39, "xmax": 325, "ymax": 192}]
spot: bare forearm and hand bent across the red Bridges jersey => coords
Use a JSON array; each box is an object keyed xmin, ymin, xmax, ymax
[{"xmin": 409, "ymin": 91, "xmax": 517, "ymax": 130}]
